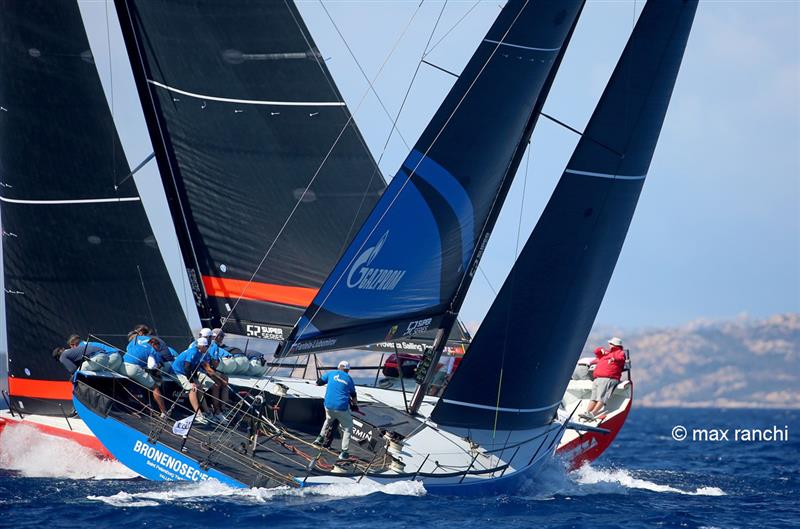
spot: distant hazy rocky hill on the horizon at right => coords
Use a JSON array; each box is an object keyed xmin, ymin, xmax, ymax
[{"xmin": 583, "ymin": 313, "xmax": 800, "ymax": 409}]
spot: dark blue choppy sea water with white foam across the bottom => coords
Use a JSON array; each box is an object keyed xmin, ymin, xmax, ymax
[{"xmin": 0, "ymin": 409, "xmax": 800, "ymax": 529}]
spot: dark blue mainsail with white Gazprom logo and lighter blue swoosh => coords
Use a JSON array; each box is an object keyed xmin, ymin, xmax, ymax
[{"xmin": 281, "ymin": 0, "xmax": 583, "ymax": 355}]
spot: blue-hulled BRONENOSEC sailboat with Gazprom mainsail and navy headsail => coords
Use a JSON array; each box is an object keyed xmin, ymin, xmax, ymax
[{"xmin": 73, "ymin": 0, "xmax": 696, "ymax": 494}]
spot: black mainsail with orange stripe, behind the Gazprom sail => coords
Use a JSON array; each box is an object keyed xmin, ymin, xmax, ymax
[{"xmin": 116, "ymin": 0, "xmax": 386, "ymax": 339}]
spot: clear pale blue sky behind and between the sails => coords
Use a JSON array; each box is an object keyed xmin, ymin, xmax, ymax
[{"xmin": 3, "ymin": 0, "xmax": 800, "ymax": 350}]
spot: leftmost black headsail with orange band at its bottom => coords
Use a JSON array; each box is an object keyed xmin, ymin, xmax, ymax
[{"xmin": 0, "ymin": 0, "xmax": 191, "ymax": 414}]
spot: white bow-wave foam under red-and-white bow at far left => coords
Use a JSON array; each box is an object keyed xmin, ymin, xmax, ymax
[{"xmin": 0, "ymin": 418, "xmax": 136, "ymax": 479}]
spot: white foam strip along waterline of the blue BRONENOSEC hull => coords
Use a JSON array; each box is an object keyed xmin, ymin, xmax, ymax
[{"xmin": 87, "ymin": 479, "xmax": 426, "ymax": 507}]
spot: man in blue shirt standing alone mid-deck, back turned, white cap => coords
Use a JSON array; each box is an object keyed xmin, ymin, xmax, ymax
[{"xmin": 314, "ymin": 360, "xmax": 358, "ymax": 459}]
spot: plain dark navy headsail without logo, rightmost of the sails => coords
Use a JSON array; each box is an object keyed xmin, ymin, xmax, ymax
[{"xmin": 432, "ymin": 0, "xmax": 697, "ymax": 429}]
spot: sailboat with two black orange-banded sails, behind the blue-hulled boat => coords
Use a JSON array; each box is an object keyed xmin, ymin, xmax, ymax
[{"xmin": 0, "ymin": 2, "xmax": 468, "ymax": 450}]
